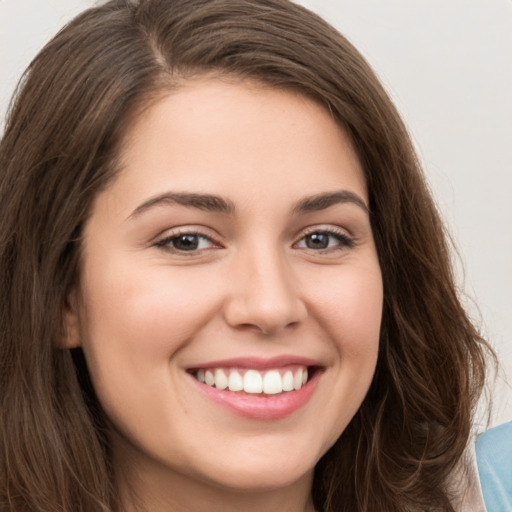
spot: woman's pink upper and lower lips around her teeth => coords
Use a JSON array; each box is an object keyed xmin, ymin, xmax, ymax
[{"xmin": 190, "ymin": 356, "xmax": 322, "ymax": 421}]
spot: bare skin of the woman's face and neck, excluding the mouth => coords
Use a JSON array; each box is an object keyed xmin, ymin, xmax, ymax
[{"xmin": 66, "ymin": 77, "xmax": 382, "ymax": 512}]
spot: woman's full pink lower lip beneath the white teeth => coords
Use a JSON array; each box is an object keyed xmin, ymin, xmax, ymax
[{"xmin": 191, "ymin": 371, "xmax": 320, "ymax": 420}]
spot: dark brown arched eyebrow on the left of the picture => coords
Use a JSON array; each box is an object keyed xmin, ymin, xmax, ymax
[{"xmin": 128, "ymin": 192, "xmax": 235, "ymax": 219}]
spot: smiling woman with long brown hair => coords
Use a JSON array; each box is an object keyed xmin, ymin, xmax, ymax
[{"xmin": 0, "ymin": 0, "xmax": 492, "ymax": 512}]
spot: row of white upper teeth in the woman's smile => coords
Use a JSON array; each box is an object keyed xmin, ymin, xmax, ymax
[{"xmin": 195, "ymin": 366, "xmax": 308, "ymax": 395}]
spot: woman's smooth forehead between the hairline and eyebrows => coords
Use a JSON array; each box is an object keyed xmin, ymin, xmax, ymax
[{"xmin": 96, "ymin": 77, "xmax": 367, "ymax": 220}]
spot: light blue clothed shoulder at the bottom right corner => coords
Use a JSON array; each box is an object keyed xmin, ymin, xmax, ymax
[{"xmin": 476, "ymin": 421, "xmax": 512, "ymax": 512}]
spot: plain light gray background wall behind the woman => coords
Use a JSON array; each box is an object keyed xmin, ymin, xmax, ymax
[{"xmin": 0, "ymin": 0, "xmax": 512, "ymax": 424}]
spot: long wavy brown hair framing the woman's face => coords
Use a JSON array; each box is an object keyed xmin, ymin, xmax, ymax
[{"xmin": 0, "ymin": 0, "xmax": 486, "ymax": 512}]
